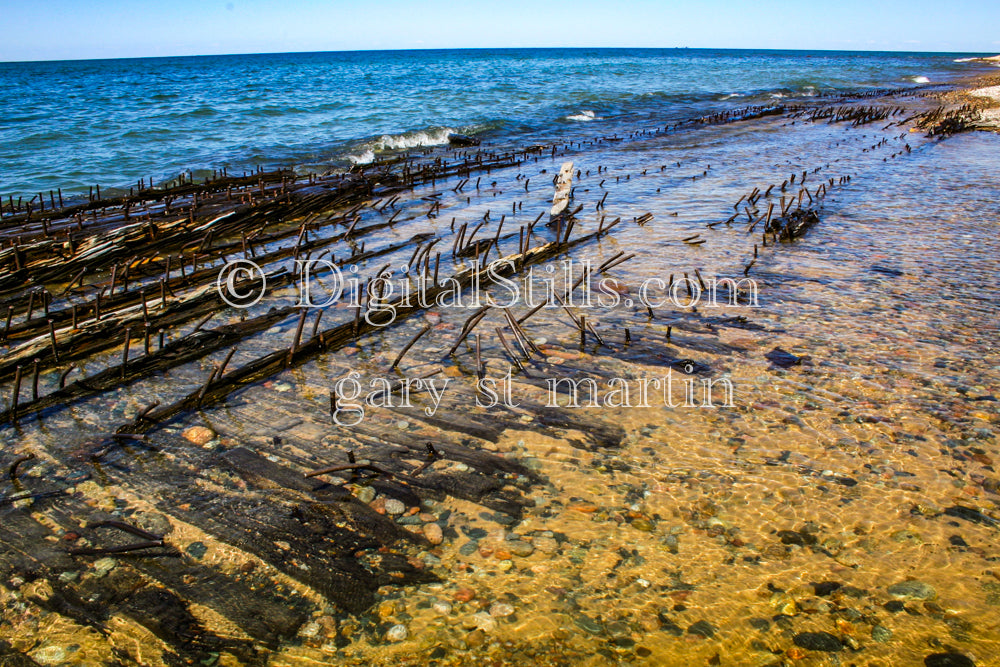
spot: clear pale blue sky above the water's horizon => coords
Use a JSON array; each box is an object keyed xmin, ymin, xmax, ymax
[{"xmin": 0, "ymin": 0, "xmax": 1000, "ymax": 61}]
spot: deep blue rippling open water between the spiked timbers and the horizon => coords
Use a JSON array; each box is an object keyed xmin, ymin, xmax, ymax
[{"xmin": 0, "ymin": 49, "xmax": 982, "ymax": 196}]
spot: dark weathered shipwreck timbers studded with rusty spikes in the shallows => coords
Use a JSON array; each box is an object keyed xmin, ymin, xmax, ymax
[{"xmin": 0, "ymin": 81, "xmax": 992, "ymax": 664}]
